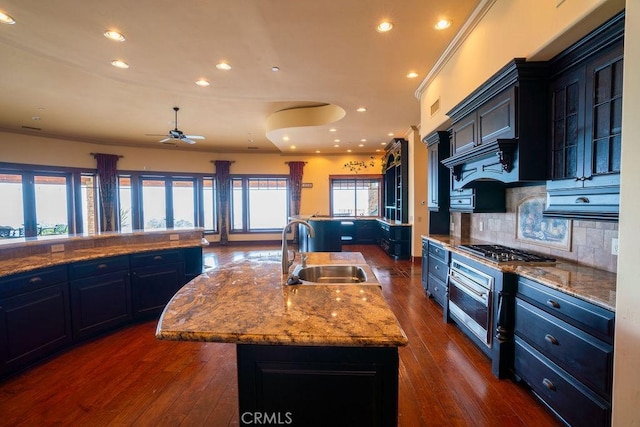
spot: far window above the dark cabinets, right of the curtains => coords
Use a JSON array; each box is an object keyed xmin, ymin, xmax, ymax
[{"xmin": 329, "ymin": 176, "xmax": 382, "ymax": 216}]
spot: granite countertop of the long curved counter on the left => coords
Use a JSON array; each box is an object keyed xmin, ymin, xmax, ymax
[{"xmin": 0, "ymin": 230, "xmax": 202, "ymax": 277}]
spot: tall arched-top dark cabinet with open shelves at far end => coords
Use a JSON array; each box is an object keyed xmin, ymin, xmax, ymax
[{"xmin": 384, "ymin": 138, "xmax": 409, "ymax": 224}]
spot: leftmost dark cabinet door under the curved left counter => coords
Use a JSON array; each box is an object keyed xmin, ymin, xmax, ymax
[{"xmin": 0, "ymin": 282, "xmax": 72, "ymax": 373}]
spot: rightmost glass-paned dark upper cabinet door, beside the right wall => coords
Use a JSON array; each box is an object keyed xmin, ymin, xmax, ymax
[{"xmin": 581, "ymin": 45, "xmax": 623, "ymax": 187}]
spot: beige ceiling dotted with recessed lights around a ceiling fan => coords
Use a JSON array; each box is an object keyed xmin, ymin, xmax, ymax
[{"xmin": 0, "ymin": 0, "xmax": 479, "ymax": 155}]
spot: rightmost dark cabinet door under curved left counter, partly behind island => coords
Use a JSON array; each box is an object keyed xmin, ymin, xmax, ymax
[{"xmin": 131, "ymin": 263, "xmax": 185, "ymax": 318}]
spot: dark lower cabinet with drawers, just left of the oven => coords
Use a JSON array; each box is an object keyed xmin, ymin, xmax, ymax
[{"xmin": 422, "ymin": 239, "xmax": 449, "ymax": 310}]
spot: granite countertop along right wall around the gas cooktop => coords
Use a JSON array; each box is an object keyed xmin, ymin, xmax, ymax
[{"xmin": 422, "ymin": 235, "xmax": 617, "ymax": 311}]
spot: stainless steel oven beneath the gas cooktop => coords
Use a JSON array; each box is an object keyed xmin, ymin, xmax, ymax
[{"xmin": 449, "ymin": 260, "xmax": 494, "ymax": 348}]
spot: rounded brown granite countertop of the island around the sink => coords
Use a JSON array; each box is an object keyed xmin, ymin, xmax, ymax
[{"xmin": 156, "ymin": 252, "xmax": 408, "ymax": 347}]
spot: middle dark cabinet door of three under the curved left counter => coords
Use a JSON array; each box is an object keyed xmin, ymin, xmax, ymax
[{"xmin": 71, "ymin": 270, "xmax": 131, "ymax": 338}]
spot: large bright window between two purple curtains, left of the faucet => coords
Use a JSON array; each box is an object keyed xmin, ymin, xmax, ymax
[{"xmin": 231, "ymin": 176, "xmax": 289, "ymax": 232}]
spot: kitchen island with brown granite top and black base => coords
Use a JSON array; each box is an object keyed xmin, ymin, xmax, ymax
[{"xmin": 156, "ymin": 252, "xmax": 407, "ymax": 425}]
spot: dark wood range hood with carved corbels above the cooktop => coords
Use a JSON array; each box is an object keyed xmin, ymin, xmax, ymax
[{"xmin": 442, "ymin": 58, "xmax": 548, "ymax": 190}]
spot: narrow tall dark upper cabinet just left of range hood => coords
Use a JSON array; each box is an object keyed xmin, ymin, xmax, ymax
[{"xmin": 422, "ymin": 131, "xmax": 450, "ymax": 234}]
